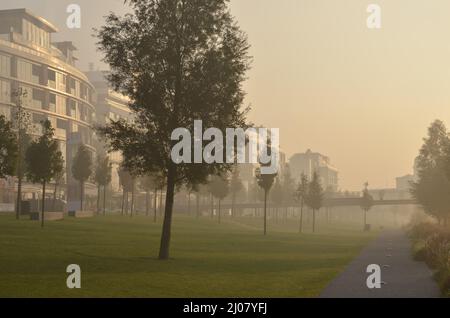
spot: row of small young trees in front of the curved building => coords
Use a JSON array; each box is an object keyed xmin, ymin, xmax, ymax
[{"xmin": 0, "ymin": 102, "xmax": 111, "ymax": 226}]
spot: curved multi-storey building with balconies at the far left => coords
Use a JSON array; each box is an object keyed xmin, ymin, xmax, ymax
[{"xmin": 0, "ymin": 9, "xmax": 95, "ymax": 208}]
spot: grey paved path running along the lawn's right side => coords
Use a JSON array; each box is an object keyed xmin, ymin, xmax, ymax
[{"xmin": 320, "ymin": 230, "xmax": 440, "ymax": 298}]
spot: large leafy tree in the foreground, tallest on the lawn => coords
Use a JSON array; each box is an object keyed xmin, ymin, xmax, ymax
[{"xmin": 97, "ymin": 0, "xmax": 250, "ymax": 260}]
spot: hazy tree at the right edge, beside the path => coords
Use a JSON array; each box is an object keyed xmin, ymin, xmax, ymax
[{"xmin": 411, "ymin": 120, "xmax": 450, "ymax": 225}]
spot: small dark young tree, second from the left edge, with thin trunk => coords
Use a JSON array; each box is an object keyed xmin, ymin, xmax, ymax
[{"xmin": 25, "ymin": 120, "xmax": 64, "ymax": 227}]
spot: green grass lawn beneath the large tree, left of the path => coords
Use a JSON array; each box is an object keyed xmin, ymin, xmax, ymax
[{"xmin": 0, "ymin": 215, "xmax": 376, "ymax": 297}]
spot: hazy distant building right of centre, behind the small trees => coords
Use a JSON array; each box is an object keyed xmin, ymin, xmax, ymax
[{"xmin": 289, "ymin": 150, "xmax": 338, "ymax": 191}]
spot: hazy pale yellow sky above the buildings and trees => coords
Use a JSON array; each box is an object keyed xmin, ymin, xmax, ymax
[{"xmin": 0, "ymin": 0, "xmax": 450, "ymax": 190}]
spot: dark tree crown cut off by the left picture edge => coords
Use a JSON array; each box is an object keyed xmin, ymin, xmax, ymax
[{"xmin": 0, "ymin": 115, "xmax": 18, "ymax": 178}]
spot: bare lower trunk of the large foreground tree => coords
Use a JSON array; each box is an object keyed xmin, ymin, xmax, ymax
[{"xmin": 159, "ymin": 164, "xmax": 177, "ymax": 260}]
